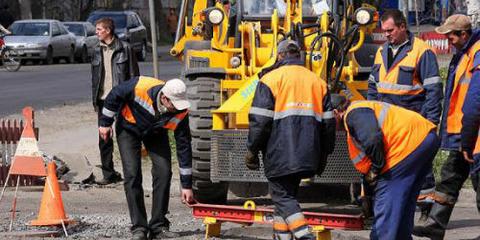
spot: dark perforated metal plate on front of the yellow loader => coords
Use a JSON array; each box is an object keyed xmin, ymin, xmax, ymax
[{"xmin": 210, "ymin": 129, "xmax": 360, "ymax": 184}]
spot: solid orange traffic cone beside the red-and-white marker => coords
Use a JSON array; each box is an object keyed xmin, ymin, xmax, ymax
[{"xmin": 30, "ymin": 162, "xmax": 72, "ymax": 226}]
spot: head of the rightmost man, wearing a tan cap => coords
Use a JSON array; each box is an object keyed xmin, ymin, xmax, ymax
[{"xmin": 435, "ymin": 14, "xmax": 472, "ymax": 50}]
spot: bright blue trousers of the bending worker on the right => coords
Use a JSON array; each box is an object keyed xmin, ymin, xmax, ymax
[{"xmin": 370, "ymin": 133, "xmax": 440, "ymax": 240}]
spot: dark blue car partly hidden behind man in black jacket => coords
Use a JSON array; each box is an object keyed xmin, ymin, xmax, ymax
[{"xmin": 87, "ymin": 11, "xmax": 147, "ymax": 61}]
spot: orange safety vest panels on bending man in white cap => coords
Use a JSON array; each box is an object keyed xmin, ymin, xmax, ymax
[{"xmin": 121, "ymin": 76, "xmax": 188, "ymax": 130}]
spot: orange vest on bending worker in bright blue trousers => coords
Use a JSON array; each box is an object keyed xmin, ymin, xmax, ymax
[{"xmin": 344, "ymin": 101, "xmax": 435, "ymax": 174}]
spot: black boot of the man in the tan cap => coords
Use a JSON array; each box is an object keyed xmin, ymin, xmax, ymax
[{"xmin": 413, "ymin": 203, "xmax": 454, "ymax": 240}]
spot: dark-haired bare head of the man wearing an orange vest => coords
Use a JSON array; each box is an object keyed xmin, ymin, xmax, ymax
[{"xmin": 380, "ymin": 9, "xmax": 408, "ymax": 45}]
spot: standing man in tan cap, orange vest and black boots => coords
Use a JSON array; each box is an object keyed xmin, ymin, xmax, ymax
[{"xmin": 413, "ymin": 14, "xmax": 480, "ymax": 239}]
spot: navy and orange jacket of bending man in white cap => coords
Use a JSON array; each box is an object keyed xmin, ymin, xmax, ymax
[{"xmin": 99, "ymin": 76, "xmax": 192, "ymax": 188}]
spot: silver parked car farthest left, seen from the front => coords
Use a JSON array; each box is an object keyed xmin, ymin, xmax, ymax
[{"xmin": 5, "ymin": 19, "xmax": 75, "ymax": 64}]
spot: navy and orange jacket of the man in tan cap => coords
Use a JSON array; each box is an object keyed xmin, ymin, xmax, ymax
[{"xmin": 440, "ymin": 30, "xmax": 480, "ymax": 151}]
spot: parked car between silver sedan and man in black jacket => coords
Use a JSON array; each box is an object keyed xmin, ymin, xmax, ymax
[{"xmin": 63, "ymin": 22, "xmax": 98, "ymax": 63}]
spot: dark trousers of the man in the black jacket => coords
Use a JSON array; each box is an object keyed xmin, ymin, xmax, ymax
[{"xmin": 97, "ymin": 100, "xmax": 115, "ymax": 179}]
